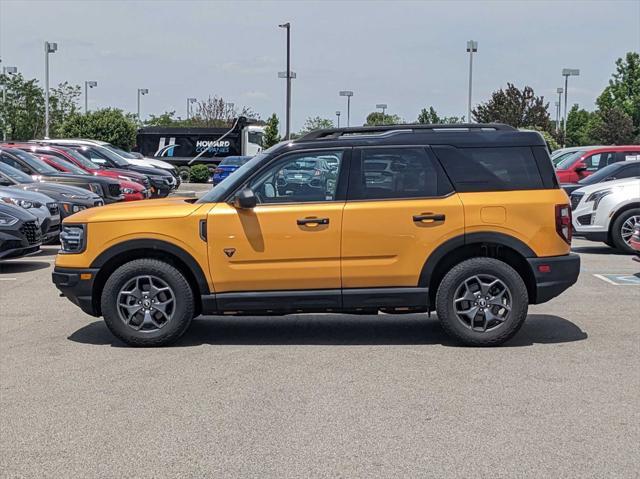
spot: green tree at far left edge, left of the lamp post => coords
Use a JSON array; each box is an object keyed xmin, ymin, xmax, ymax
[{"xmin": 0, "ymin": 74, "xmax": 44, "ymax": 140}]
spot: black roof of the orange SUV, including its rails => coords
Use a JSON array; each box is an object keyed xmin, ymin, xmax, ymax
[{"xmin": 292, "ymin": 123, "xmax": 546, "ymax": 147}]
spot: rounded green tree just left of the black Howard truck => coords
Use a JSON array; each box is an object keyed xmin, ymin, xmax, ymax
[{"xmin": 59, "ymin": 108, "xmax": 138, "ymax": 150}]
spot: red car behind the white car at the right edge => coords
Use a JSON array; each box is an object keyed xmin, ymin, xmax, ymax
[{"xmin": 556, "ymin": 145, "xmax": 640, "ymax": 183}]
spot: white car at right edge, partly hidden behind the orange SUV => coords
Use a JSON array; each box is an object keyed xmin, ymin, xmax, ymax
[{"xmin": 571, "ymin": 177, "xmax": 640, "ymax": 253}]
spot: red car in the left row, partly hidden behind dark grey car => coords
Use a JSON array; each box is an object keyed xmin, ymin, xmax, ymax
[{"xmin": 6, "ymin": 143, "xmax": 151, "ymax": 190}]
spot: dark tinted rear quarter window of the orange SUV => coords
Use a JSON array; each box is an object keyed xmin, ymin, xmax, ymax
[{"xmin": 433, "ymin": 146, "xmax": 545, "ymax": 192}]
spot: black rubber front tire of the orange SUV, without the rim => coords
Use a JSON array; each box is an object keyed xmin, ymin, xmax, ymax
[{"xmin": 100, "ymin": 259, "xmax": 195, "ymax": 347}]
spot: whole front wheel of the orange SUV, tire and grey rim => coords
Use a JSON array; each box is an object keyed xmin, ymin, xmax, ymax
[{"xmin": 101, "ymin": 259, "xmax": 194, "ymax": 346}]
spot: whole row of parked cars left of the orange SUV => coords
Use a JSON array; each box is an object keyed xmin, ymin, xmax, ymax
[{"xmin": 0, "ymin": 140, "xmax": 180, "ymax": 258}]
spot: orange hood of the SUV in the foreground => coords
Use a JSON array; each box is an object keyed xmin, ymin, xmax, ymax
[{"xmin": 63, "ymin": 197, "xmax": 204, "ymax": 223}]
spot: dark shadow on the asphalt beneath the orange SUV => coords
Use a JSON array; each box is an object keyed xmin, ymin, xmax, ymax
[{"xmin": 68, "ymin": 314, "xmax": 587, "ymax": 347}]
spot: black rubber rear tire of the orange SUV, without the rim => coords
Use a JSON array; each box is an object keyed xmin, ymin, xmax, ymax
[{"xmin": 436, "ymin": 258, "xmax": 529, "ymax": 346}]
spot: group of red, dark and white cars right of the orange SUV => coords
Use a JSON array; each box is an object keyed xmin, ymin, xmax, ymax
[{"xmin": 552, "ymin": 145, "xmax": 640, "ymax": 253}]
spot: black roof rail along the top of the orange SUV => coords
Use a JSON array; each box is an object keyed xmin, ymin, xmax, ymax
[{"xmin": 296, "ymin": 123, "xmax": 516, "ymax": 141}]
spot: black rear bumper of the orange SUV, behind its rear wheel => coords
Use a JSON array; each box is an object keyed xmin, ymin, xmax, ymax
[{"xmin": 527, "ymin": 253, "xmax": 580, "ymax": 304}]
